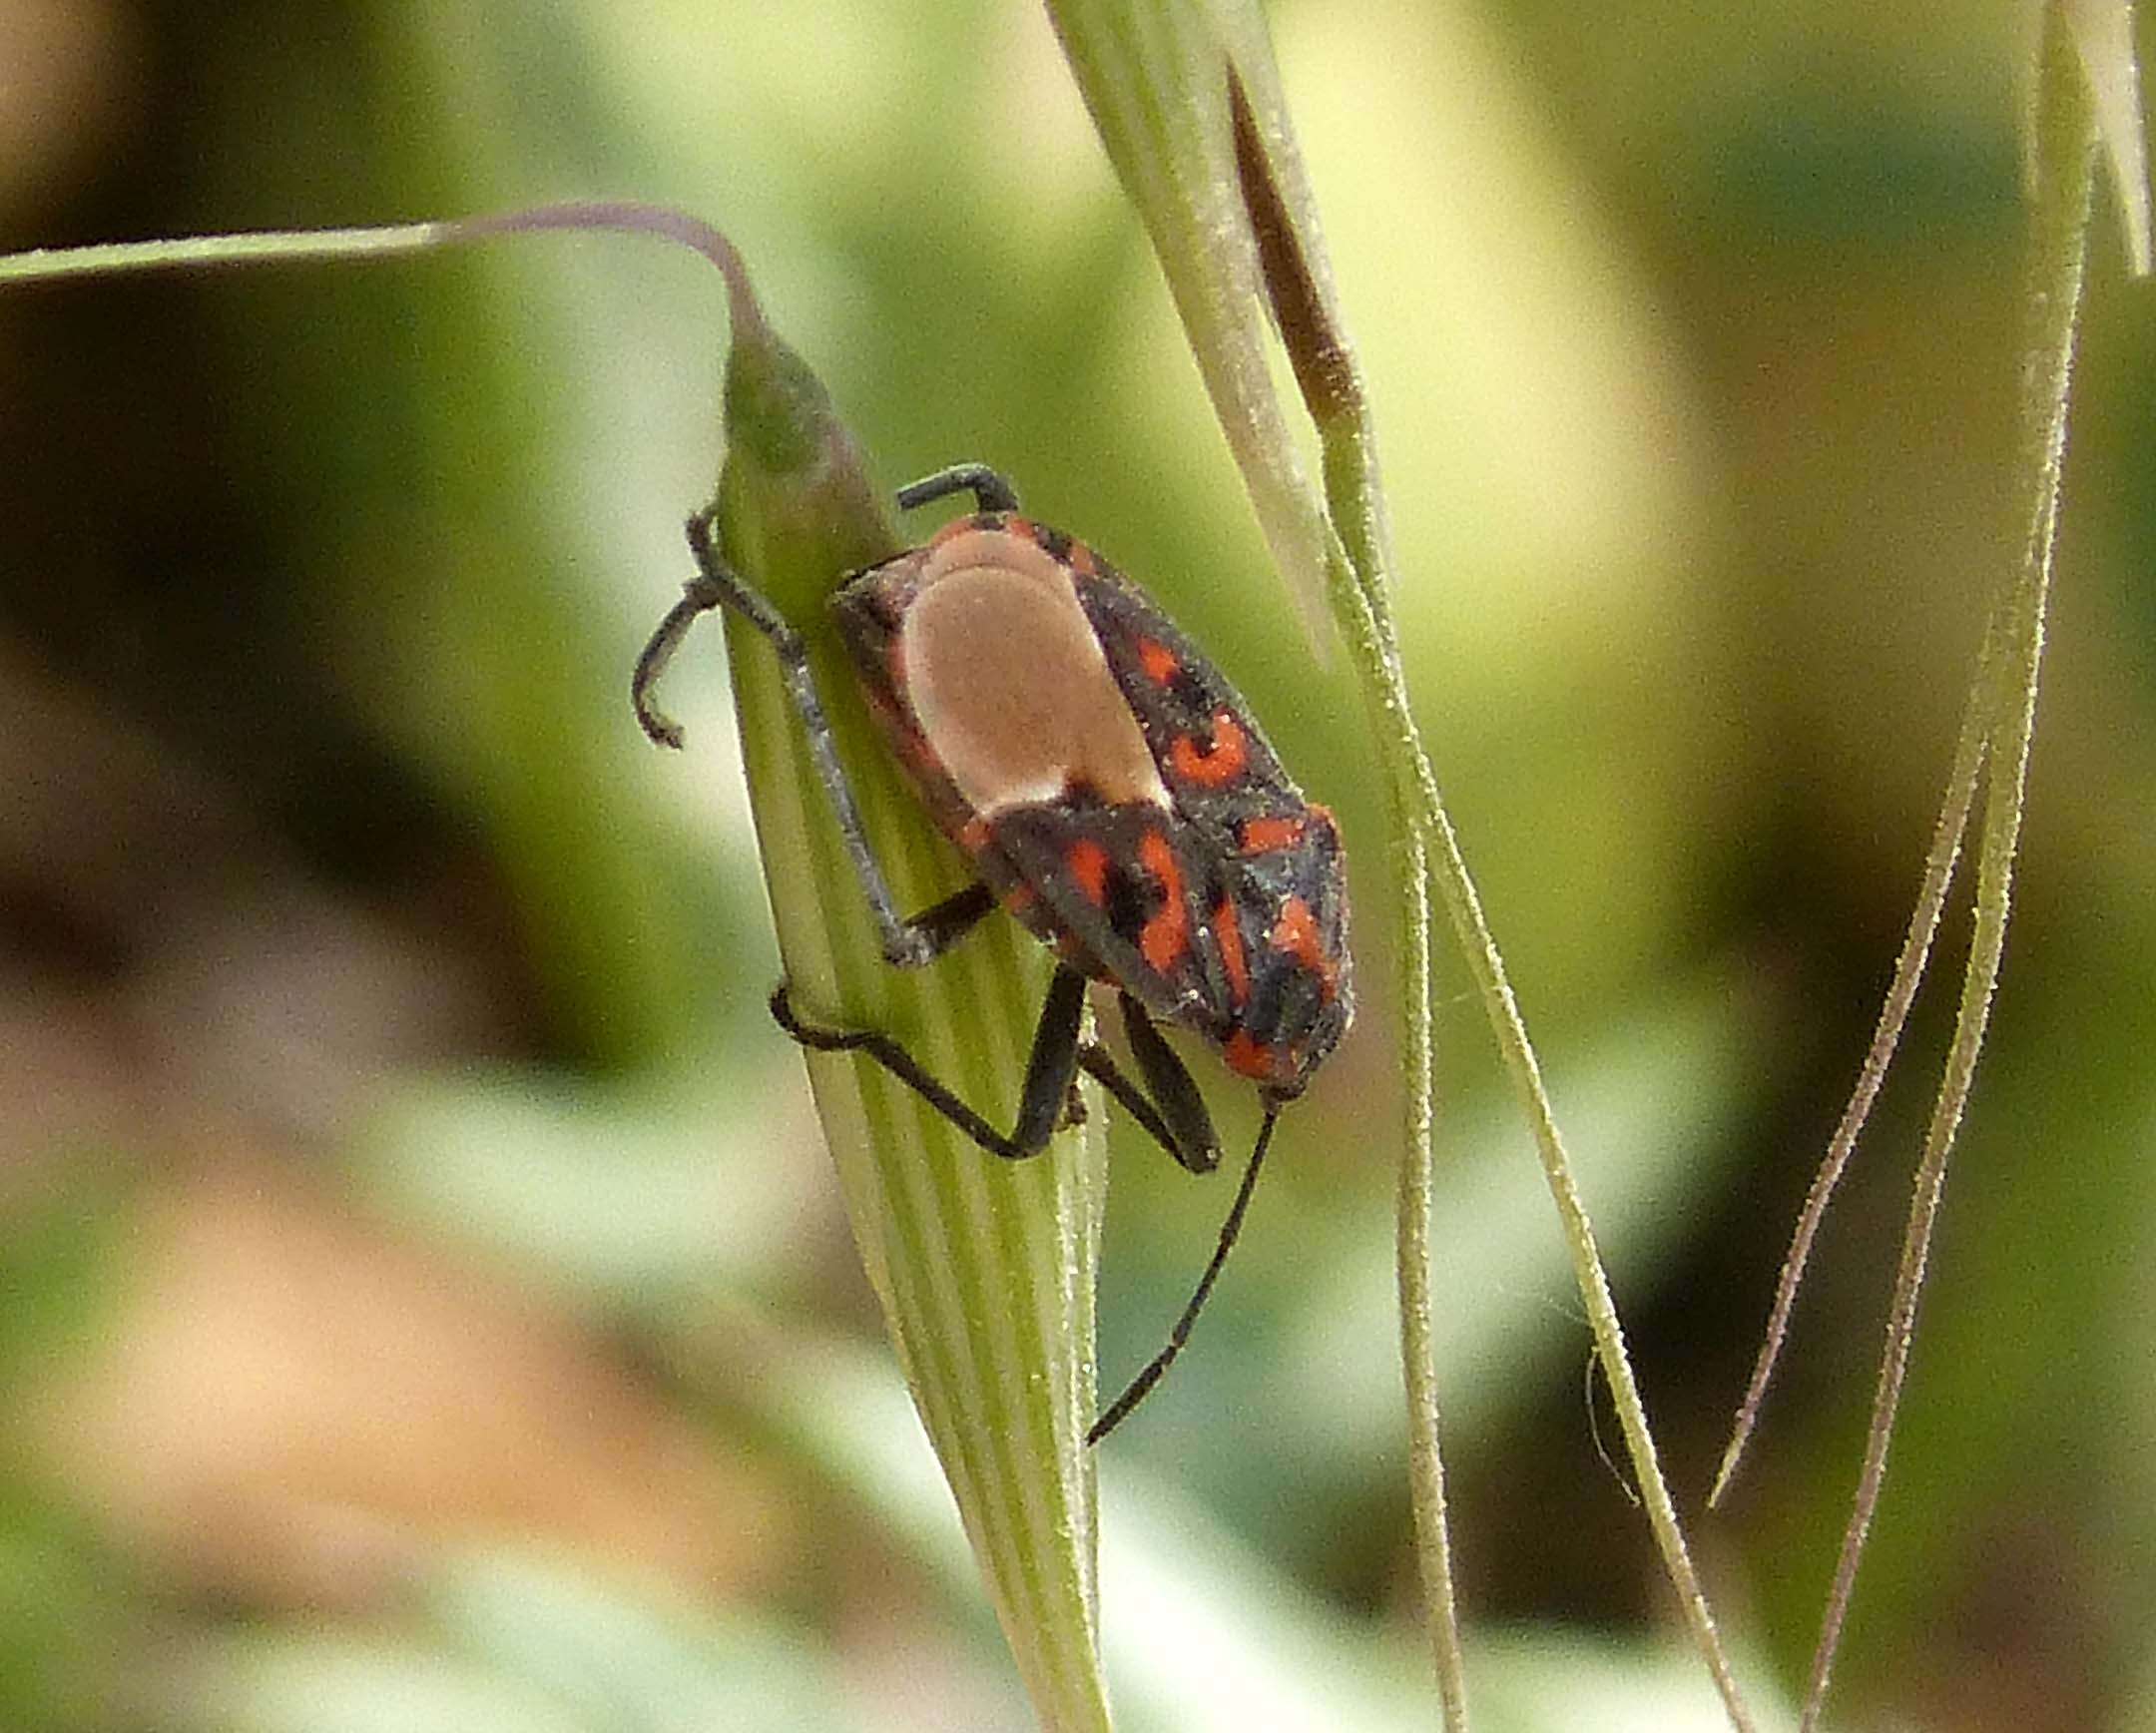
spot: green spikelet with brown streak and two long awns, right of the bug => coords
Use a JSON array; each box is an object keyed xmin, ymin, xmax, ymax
[{"xmin": 1050, "ymin": 0, "xmax": 1751, "ymax": 1729}]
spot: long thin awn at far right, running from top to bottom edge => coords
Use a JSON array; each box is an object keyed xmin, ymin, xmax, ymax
[{"xmin": 1801, "ymin": 6, "xmax": 2098, "ymax": 1733}]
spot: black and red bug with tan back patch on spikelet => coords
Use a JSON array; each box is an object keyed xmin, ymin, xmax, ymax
[{"xmin": 634, "ymin": 463, "xmax": 1353, "ymax": 1444}]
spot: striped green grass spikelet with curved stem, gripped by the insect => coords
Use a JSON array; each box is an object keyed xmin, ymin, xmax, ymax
[{"xmin": 0, "ymin": 205, "xmax": 1110, "ymax": 1733}]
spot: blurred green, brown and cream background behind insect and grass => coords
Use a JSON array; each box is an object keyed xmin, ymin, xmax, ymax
[{"xmin": 0, "ymin": 0, "xmax": 2156, "ymax": 1733}]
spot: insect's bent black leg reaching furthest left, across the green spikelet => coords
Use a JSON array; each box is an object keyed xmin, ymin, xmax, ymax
[{"xmin": 630, "ymin": 511, "xmax": 935, "ymax": 967}]
